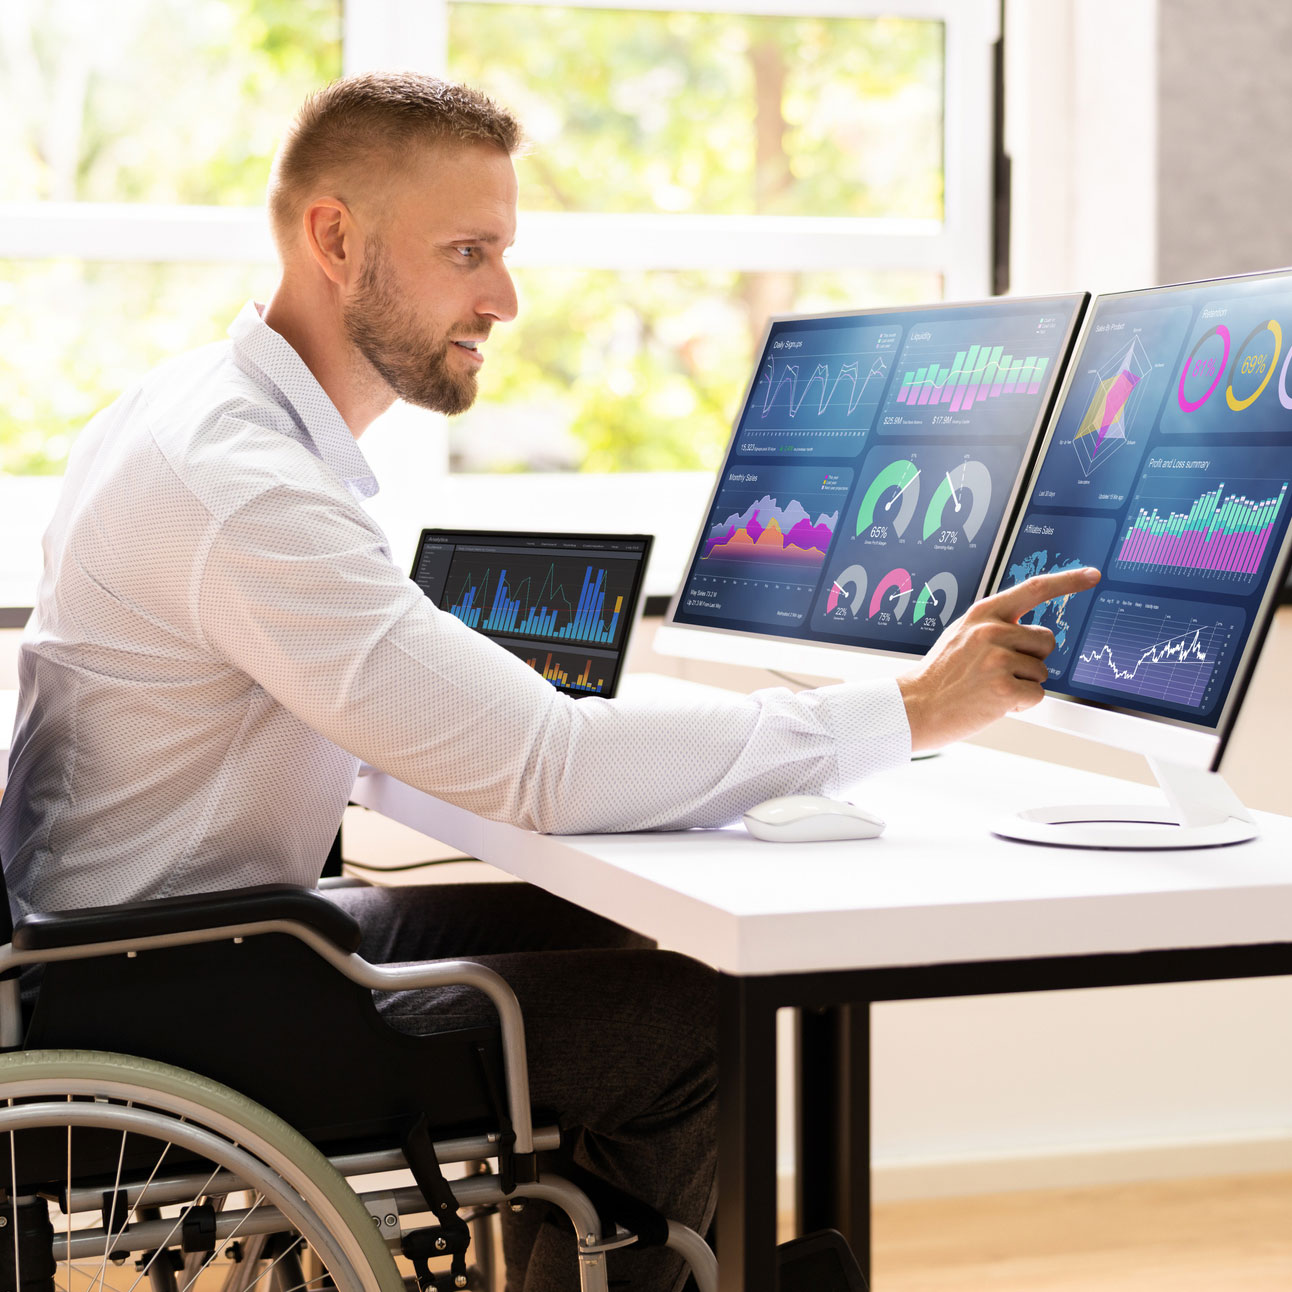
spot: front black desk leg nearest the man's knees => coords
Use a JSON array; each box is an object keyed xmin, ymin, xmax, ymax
[{"xmin": 717, "ymin": 974, "xmax": 776, "ymax": 1292}]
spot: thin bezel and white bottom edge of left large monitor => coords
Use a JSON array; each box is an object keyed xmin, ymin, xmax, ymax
[{"xmin": 656, "ymin": 292, "xmax": 1090, "ymax": 677}]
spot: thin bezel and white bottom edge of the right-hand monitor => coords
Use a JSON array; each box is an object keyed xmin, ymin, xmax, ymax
[{"xmin": 988, "ymin": 266, "xmax": 1292, "ymax": 771}]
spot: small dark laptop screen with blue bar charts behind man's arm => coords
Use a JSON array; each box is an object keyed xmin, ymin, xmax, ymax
[{"xmin": 412, "ymin": 530, "xmax": 651, "ymax": 696}]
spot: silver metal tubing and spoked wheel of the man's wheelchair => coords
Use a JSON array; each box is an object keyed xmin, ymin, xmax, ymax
[{"xmin": 0, "ymin": 890, "xmax": 717, "ymax": 1292}]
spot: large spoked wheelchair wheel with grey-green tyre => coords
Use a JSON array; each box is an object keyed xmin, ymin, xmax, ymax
[{"xmin": 0, "ymin": 1050, "xmax": 403, "ymax": 1292}]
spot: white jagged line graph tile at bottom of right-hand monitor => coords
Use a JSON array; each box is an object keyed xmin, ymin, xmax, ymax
[{"xmin": 1072, "ymin": 593, "xmax": 1244, "ymax": 712}]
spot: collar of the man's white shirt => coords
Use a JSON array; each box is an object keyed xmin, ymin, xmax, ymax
[{"xmin": 229, "ymin": 301, "xmax": 380, "ymax": 499}]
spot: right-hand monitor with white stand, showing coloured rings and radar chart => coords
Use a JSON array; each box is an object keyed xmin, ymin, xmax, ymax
[{"xmin": 981, "ymin": 270, "xmax": 1292, "ymax": 848}]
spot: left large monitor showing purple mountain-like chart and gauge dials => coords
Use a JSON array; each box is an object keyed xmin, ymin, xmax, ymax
[{"xmin": 655, "ymin": 295, "xmax": 1088, "ymax": 678}]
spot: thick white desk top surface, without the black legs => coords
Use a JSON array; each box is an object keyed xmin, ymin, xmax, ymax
[{"xmin": 355, "ymin": 745, "xmax": 1292, "ymax": 974}]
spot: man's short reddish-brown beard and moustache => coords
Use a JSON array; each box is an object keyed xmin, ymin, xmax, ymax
[{"xmin": 342, "ymin": 239, "xmax": 490, "ymax": 416}]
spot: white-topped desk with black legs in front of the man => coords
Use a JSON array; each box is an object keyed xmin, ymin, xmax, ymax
[{"xmin": 354, "ymin": 747, "xmax": 1292, "ymax": 1292}]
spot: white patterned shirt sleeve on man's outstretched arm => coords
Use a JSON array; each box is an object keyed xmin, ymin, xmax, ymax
[{"xmin": 198, "ymin": 486, "xmax": 911, "ymax": 833}]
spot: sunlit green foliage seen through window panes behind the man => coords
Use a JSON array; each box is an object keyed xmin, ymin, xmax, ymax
[{"xmin": 0, "ymin": 0, "xmax": 943, "ymax": 474}]
